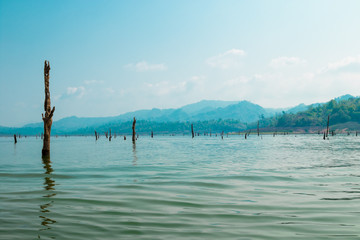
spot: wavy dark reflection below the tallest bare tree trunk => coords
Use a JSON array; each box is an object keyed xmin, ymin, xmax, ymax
[{"xmin": 39, "ymin": 157, "xmax": 56, "ymax": 236}]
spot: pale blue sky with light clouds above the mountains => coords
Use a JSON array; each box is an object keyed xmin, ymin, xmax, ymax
[{"xmin": 0, "ymin": 0, "xmax": 360, "ymax": 126}]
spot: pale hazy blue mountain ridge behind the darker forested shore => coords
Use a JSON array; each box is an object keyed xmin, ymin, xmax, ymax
[{"xmin": 0, "ymin": 94, "xmax": 354, "ymax": 135}]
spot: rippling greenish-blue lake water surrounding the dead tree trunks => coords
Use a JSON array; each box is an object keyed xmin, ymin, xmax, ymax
[{"xmin": 0, "ymin": 135, "xmax": 360, "ymax": 240}]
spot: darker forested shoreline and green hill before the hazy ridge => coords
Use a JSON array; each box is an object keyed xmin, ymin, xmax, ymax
[{"xmin": 0, "ymin": 97, "xmax": 360, "ymax": 136}]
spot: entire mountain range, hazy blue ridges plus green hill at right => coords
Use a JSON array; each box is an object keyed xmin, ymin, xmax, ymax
[{"xmin": 0, "ymin": 95, "xmax": 360, "ymax": 135}]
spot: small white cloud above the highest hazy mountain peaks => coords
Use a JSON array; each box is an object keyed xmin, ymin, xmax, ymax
[{"xmin": 206, "ymin": 49, "xmax": 245, "ymax": 69}]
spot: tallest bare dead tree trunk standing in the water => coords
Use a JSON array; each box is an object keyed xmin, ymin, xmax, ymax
[{"xmin": 42, "ymin": 61, "xmax": 55, "ymax": 157}]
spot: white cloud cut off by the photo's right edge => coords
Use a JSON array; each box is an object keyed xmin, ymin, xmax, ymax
[{"xmin": 319, "ymin": 55, "xmax": 360, "ymax": 73}]
